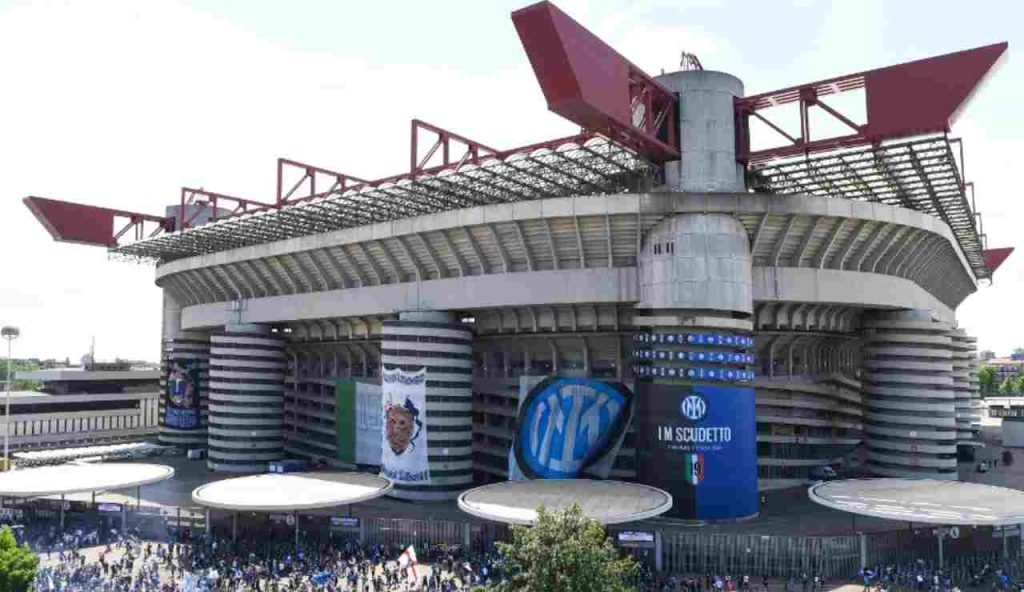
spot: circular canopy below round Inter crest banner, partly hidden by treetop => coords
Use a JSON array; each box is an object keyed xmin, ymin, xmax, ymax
[{"xmin": 459, "ymin": 479, "xmax": 672, "ymax": 524}]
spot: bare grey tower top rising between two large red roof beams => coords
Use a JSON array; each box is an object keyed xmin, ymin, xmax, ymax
[{"xmin": 656, "ymin": 70, "xmax": 746, "ymax": 193}]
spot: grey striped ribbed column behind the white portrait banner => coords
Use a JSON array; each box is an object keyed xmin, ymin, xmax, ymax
[{"xmin": 381, "ymin": 311, "xmax": 473, "ymax": 500}]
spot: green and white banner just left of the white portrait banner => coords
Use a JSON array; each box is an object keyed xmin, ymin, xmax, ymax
[{"xmin": 334, "ymin": 379, "xmax": 384, "ymax": 467}]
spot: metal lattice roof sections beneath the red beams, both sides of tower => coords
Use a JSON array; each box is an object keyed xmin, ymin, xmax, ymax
[{"xmin": 112, "ymin": 133, "xmax": 987, "ymax": 278}]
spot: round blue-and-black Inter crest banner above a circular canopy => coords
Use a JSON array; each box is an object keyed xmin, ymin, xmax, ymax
[{"xmin": 509, "ymin": 376, "xmax": 633, "ymax": 480}]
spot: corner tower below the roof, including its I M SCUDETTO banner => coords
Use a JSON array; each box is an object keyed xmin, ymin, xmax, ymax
[{"xmin": 631, "ymin": 214, "xmax": 758, "ymax": 519}]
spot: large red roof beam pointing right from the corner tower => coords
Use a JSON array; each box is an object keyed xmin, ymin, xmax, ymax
[{"xmin": 735, "ymin": 42, "xmax": 1008, "ymax": 164}]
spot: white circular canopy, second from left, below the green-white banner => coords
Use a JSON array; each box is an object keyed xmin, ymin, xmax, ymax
[{"xmin": 193, "ymin": 472, "xmax": 391, "ymax": 512}]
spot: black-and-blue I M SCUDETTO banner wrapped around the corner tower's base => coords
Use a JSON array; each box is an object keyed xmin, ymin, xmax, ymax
[{"xmin": 636, "ymin": 384, "xmax": 758, "ymax": 520}]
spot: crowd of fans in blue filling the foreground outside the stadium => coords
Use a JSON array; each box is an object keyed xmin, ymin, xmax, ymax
[{"xmin": 2, "ymin": 510, "xmax": 1024, "ymax": 592}]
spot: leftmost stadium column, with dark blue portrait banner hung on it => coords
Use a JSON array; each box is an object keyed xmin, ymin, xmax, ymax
[{"xmin": 158, "ymin": 290, "xmax": 210, "ymax": 449}]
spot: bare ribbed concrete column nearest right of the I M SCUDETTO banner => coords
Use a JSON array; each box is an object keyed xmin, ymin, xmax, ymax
[{"xmin": 863, "ymin": 310, "xmax": 957, "ymax": 479}]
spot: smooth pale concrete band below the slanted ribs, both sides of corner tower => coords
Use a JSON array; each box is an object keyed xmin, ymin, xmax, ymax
[{"xmin": 174, "ymin": 267, "xmax": 953, "ymax": 330}]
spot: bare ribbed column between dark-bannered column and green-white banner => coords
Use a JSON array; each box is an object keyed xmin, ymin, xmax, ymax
[{"xmin": 207, "ymin": 325, "xmax": 286, "ymax": 472}]
